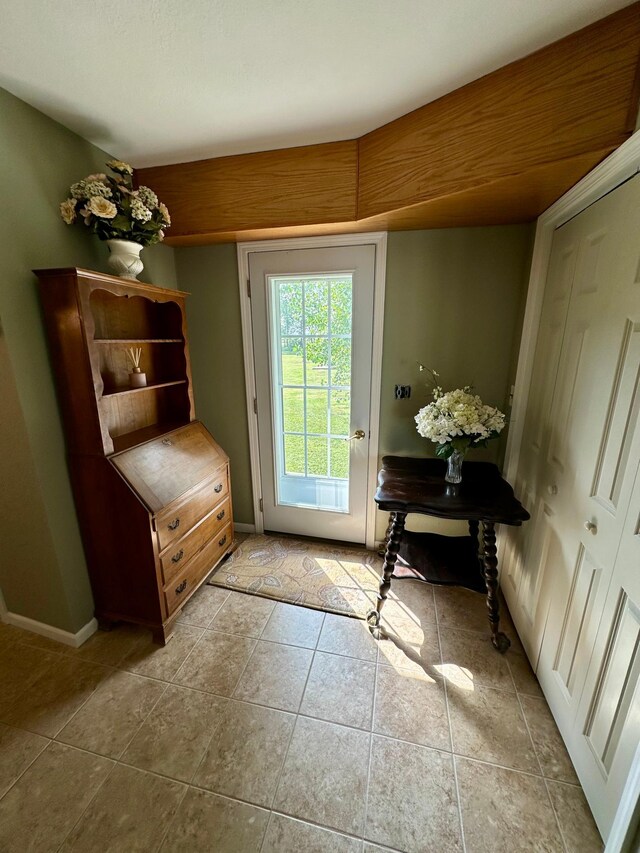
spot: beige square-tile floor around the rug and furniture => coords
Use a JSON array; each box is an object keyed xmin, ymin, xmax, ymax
[{"xmin": 0, "ymin": 580, "xmax": 602, "ymax": 853}]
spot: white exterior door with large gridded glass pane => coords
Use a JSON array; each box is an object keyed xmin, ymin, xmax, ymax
[{"xmin": 249, "ymin": 245, "xmax": 376, "ymax": 543}]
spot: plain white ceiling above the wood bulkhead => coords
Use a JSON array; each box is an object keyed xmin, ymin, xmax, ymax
[{"xmin": 0, "ymin": 0, "xmax": 628, "ymax": 167}]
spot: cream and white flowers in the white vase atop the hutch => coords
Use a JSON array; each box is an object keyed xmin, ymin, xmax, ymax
[{"xmin": 60, "ymin": 160, "xmax": 171, "ymax": 246}]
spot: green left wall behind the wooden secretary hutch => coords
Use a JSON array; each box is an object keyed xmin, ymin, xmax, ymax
[{"xmin": 0, "ymin": 89, "xmax": 176, "ymax": 632}]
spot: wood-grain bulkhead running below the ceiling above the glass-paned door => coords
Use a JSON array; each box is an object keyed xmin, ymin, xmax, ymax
[{"xmin": 136, "ymin": 2, "xmax": 640, "ymax": 246}]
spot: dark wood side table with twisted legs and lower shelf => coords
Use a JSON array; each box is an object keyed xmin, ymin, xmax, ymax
[{"xmin": 367, "ymin": 456, "xmax": 529, "ymax": 653}]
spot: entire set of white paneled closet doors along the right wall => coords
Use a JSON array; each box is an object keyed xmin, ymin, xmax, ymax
[{"xmin": 507, "ymin": 177, "xmax": 640, "ymax": 838}]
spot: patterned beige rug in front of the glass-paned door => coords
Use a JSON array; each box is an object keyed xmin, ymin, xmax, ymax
[{"xmin": 208, "ymin": 534, "xmax": 382, "ymax": 619}]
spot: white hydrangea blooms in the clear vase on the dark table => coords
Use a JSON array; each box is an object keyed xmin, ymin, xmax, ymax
[{"xmin": 415, "ymin": 365, "xmax": 505, "ymax": 459}]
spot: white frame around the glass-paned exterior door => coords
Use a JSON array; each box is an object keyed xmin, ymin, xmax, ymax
[{"xmin": 236, "ymin": 231, "xmax": 387, "ymax": 548}]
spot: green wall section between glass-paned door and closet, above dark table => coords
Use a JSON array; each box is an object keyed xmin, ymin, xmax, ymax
[{"xmin": 380, "ymin": 225, "xmax": 533, "ymax": 461}]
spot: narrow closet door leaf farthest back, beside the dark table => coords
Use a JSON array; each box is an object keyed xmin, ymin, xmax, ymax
[{"xmin": 501, "ymin": 221, "xmax": 578, "ymax": 666}]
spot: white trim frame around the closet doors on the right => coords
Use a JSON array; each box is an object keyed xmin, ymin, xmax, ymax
[{"xmin": 499, "ymin": 131, "xmax": 640, "ymax": 853}]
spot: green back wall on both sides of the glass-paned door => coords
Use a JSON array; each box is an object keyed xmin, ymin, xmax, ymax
[{"xmin": 176, "ymin": 225, "xmax": 533, "ymax": 523}]
